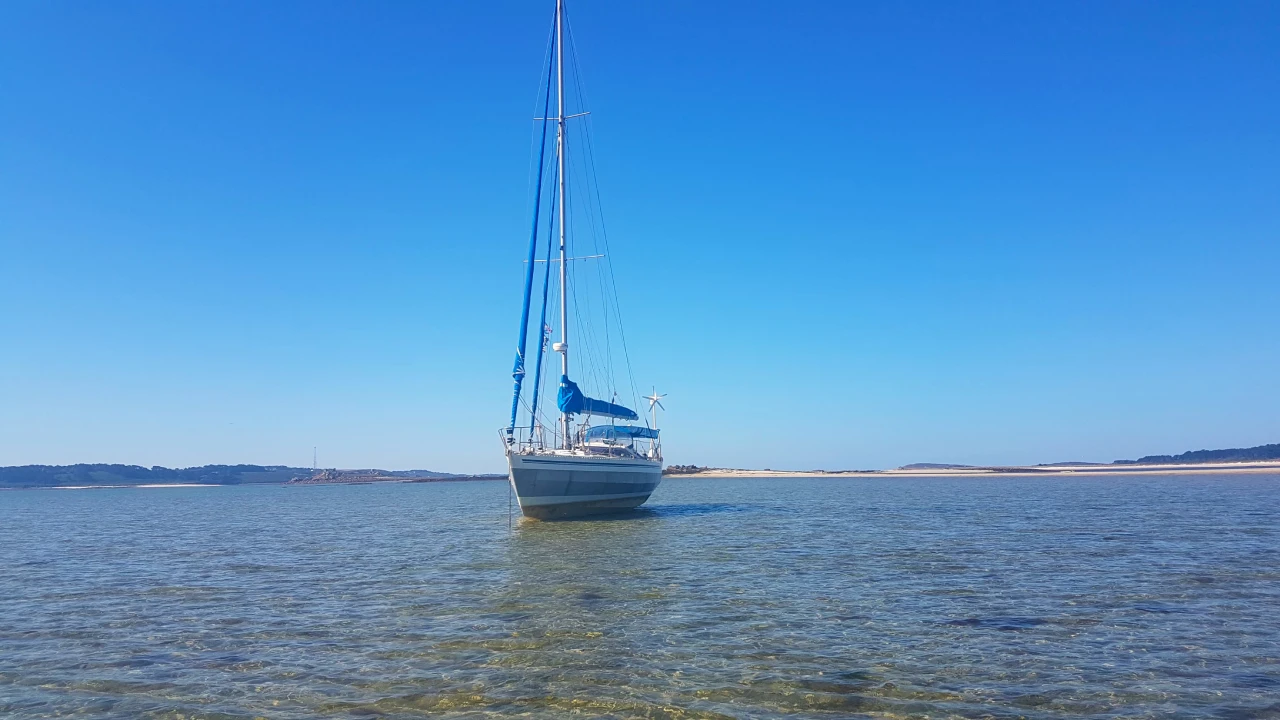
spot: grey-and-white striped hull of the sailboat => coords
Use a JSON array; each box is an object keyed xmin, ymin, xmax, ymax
[{"xmin": 507, "ymin": 451, "xmax": 662, "ymax": 520}]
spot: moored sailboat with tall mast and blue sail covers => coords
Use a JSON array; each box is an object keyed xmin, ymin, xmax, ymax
[{"xmin": 500, "ymin": 0, "xmax": 662, "ymax": 520}]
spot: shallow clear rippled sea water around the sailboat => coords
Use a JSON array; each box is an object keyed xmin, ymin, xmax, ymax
[{"xmin": 0, "ymin": 475, "xmax": 1280, "ymax": 719}]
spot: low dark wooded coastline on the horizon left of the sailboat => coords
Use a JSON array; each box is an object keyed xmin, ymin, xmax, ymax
[{"xmin": 0, "ymin": 464, "xmax": 460, "ymax": 488}]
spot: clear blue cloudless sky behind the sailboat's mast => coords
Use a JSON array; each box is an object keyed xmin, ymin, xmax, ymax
[{"xmin": 0, "ymin": 0, "xmax": 1280, "ymax": 471}]
